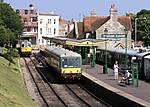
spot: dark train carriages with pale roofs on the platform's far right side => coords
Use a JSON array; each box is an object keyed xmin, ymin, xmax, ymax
[{"xmin": 96, "ymin": 49, "xmax": 150, "ymax": 80}]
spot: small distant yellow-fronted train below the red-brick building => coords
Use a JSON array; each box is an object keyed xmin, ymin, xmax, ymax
[{"xmin": 20, "ymin": 40, "xmax": 32, "ymax": 56}]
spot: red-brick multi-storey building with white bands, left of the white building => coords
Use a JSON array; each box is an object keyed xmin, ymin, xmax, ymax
[{"xmin": 16, "ymin": 4, "xmax": 38, "ymax": 45}]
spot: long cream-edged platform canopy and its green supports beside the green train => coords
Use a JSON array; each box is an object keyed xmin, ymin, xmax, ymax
[{"xmin": 43, "ymin": 37, "xmax": 105, "ymax": 67}]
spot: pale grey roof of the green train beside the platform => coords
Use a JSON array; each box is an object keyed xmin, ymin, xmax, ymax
[{"xmin": 46, "ymin": 46, "xmax": 81, "ymax": 57}]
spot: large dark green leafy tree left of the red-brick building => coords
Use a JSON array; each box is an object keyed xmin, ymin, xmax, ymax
[{"xmin": 0, "ymin": 3, "xmax": 22, "ymax": 46}]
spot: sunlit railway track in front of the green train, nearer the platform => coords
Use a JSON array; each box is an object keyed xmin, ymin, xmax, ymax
[{"xmin": 34, "ymin": 52, "xmax": 108, "ymax": 107}]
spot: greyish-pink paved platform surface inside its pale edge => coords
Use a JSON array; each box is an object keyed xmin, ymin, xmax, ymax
[{"xmin": 83, "ymin": 64, "xmax": 150, "ymax": 103}]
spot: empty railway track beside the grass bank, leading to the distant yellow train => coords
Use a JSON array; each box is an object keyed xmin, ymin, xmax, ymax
[{"xmin": 24, "ymin": 58, "xmax": 67, "ymax": 107}]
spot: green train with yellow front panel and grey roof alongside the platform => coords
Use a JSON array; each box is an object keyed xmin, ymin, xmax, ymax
[{"xmin": 40, "ymin": 46, "xmax": 82, "ymax": 80}]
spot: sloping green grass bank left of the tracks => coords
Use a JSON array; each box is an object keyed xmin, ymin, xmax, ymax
[{"xmin": 0, "ymin": 57, "xmax": 35, "ymax": 107}]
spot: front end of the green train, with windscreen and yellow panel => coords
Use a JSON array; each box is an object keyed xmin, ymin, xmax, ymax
[{"xmin": 61, "ymin": 56, "xmax": 82, "ymax": 80}]
